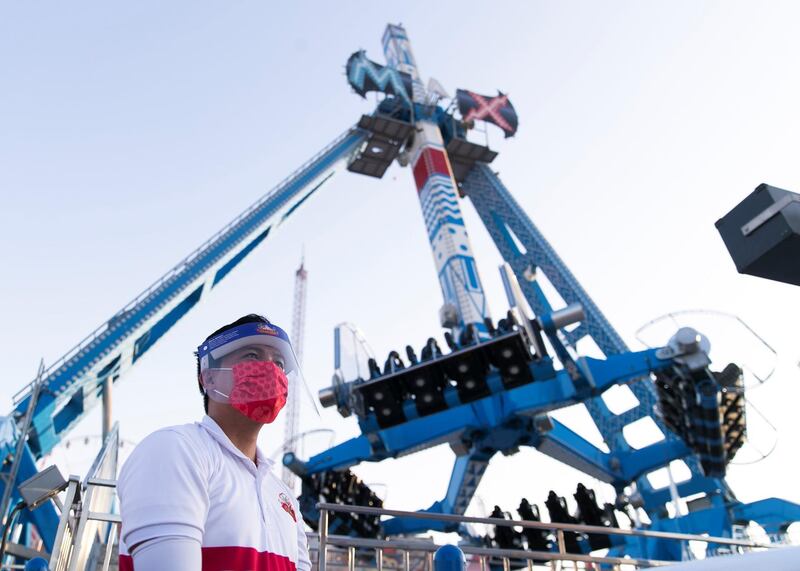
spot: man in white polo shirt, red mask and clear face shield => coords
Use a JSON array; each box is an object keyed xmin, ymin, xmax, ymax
[{"xmin": 117, "ymin": 314, "xmax": 311, "ymax": 571}]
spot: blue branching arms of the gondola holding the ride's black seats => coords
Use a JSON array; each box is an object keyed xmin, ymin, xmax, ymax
[{"xmin": 297, "ymin": 349, "xmax": 704, "ymax": 535}]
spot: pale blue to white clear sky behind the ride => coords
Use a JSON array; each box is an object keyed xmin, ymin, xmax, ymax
[{"xmin": 0, "ymin": 0, "xmax": 800, "ymax": 532}]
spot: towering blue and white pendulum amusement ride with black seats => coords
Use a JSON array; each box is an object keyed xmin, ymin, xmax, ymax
[{"xmin": 0, "ymin": 21, "xmax": 800, "ymax": 561}]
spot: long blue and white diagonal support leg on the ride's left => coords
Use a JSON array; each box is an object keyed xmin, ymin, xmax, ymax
[{"xmin": 0, "ymin": 128, "xmax": 367, "ymax": 550}]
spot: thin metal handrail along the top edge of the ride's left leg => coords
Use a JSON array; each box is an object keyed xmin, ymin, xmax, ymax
[{"xmin": 13, "ymin": 127, "xmax": 366, "ymax": 406}]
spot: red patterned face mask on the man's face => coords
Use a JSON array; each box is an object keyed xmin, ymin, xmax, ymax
[{"xmin": 229, "ymin": 361, "xmax": 289, "ymax": 424}]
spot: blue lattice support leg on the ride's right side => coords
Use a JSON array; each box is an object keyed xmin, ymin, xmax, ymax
[{"xmin": 462, "ymin": 163, "xmax": 800, "ymax": 557}]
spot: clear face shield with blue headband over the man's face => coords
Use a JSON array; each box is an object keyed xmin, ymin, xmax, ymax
[{"xmin": 197, "ymin": 323, "xmax": 319, "ymax": 422}]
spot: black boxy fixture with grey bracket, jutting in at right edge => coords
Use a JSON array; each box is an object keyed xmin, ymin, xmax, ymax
[{"xmin": 716, "ymin": 184, "xmax": 800, "ymax": 285}]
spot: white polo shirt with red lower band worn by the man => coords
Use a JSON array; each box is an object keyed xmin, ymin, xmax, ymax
[{"xmin": 117, "ymin": 416, "xmax": 311, "ymax": 571}]
